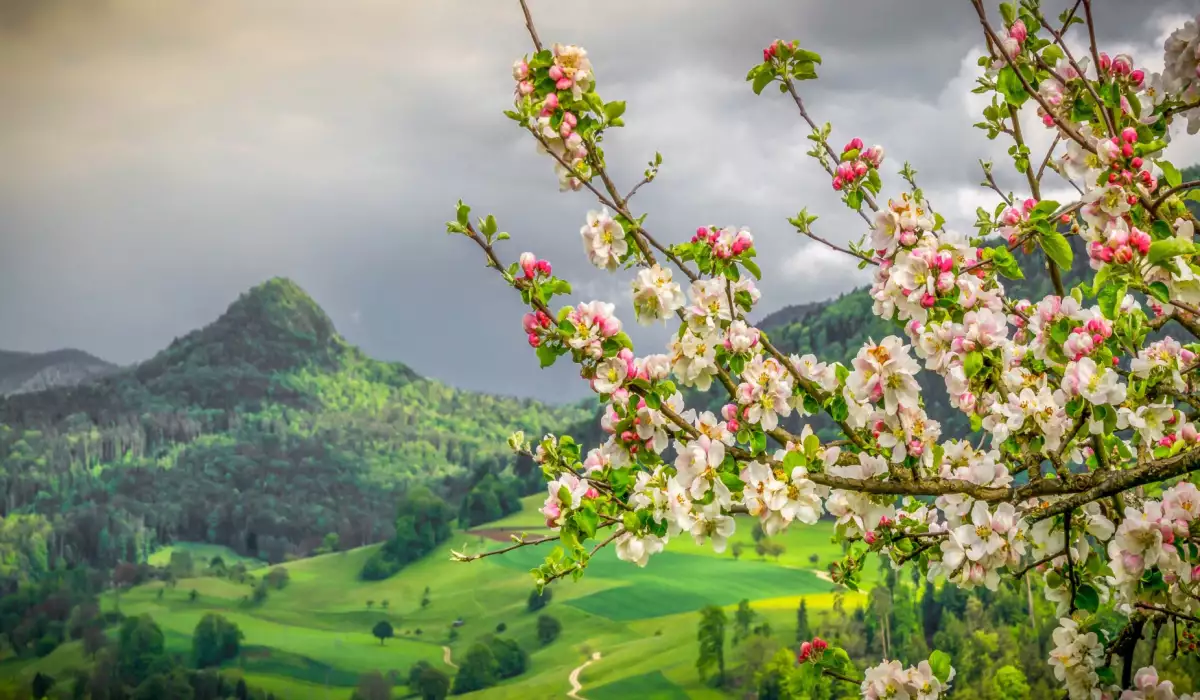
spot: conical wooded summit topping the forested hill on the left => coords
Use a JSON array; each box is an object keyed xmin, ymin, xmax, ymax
[{"xmin": 138, "ymin": 277, "xmax": 349, "ymax": 379}]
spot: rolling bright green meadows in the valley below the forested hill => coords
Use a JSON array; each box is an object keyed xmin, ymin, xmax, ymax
[{"xmin": 0, "ymin": 497, "xmax": 862, "ymax": 700}]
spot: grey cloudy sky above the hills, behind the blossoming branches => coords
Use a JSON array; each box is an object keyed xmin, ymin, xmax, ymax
[{"xmin": 0, "ymin": 0, "xmax": 1200, "ymax": 400}]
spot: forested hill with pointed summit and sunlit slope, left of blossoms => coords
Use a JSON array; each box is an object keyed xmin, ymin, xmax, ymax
[{"xmin": 0, "ymin": 279, "xmax": 587, "ymax": 588}]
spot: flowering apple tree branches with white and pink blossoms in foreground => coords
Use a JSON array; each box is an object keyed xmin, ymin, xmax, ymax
[{"xmin": 446, "ymin": 0, "xmax": 1200, "ymax": 700}]
